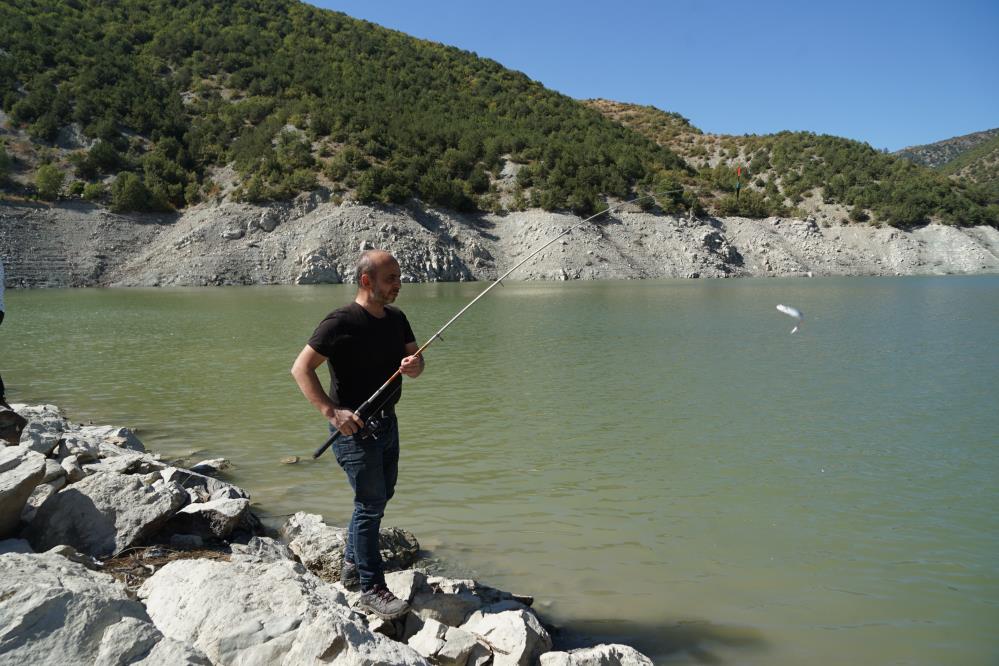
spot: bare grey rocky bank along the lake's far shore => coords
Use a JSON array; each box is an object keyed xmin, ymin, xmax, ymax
[{"xmin": 0, "ymin": 192, "xmax": 999, "ymax": 287}]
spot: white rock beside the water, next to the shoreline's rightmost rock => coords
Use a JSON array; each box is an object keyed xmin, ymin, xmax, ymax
[{"xmin": 460, "ymin": 608, "xmax": 552, "ymax": 666}]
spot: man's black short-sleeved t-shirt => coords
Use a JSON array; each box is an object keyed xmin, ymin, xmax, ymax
[{"xmin": 309, "ymin": 303, "xmax": 416, "ymax": 410}]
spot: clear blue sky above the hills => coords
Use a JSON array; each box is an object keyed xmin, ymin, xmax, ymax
[{"xmin": 312, "ymin": 0, "xmax": 999, "ymax": 150}]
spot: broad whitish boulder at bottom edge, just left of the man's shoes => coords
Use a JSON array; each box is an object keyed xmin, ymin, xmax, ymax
[{"xmin": 139, "ymin": 560, "xmax": 427, "ymax": 666}]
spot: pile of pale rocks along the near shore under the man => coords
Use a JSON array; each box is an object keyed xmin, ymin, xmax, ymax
[{"xmin": 0, "ymin": 405, "xmax": 652, "ymax": 666}]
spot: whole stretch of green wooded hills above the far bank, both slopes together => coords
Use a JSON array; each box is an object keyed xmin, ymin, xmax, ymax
[{"xmin": 0, "ymin": 0, "xmax": 999, "ymax": 225}]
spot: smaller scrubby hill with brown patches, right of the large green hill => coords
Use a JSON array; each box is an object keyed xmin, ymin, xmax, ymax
[{"xmin": 586, "ymin": 100, "xmax": 999, "ymax": 226}]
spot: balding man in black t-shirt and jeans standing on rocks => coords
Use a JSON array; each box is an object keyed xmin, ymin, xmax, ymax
[{"xmin": 291, "ymin": 250, "xmax": 424, "ymax": 620}]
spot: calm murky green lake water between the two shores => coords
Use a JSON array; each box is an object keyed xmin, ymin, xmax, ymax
[{"xmin": 0, "ymin": 276, "xmax": 999, "ymax": 665}]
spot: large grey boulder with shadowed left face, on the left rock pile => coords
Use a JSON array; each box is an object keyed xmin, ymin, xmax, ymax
[{"xmin": 24, "ymin": 472, "xmax": 187, "ymax": 557}]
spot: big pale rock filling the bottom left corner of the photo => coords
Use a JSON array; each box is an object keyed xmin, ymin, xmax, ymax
[{"xmin": 0, "ymin": 554, "xmax": 209, "ymax": 666}]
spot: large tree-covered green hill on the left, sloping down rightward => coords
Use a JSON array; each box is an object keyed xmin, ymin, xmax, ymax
[{"xmin": 0, "ymin": 0, "xmax": 687, "ymax": 213}]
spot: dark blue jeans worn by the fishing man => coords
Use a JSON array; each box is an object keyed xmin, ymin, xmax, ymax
[{"xmin": 333, "ymin": 416, "xmax": 399, "ymax": 590}]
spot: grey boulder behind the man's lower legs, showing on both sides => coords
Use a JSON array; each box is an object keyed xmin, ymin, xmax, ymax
[{"xmin": 281, "ymin": 511, "xmax": 420, "ymax": 583}]
